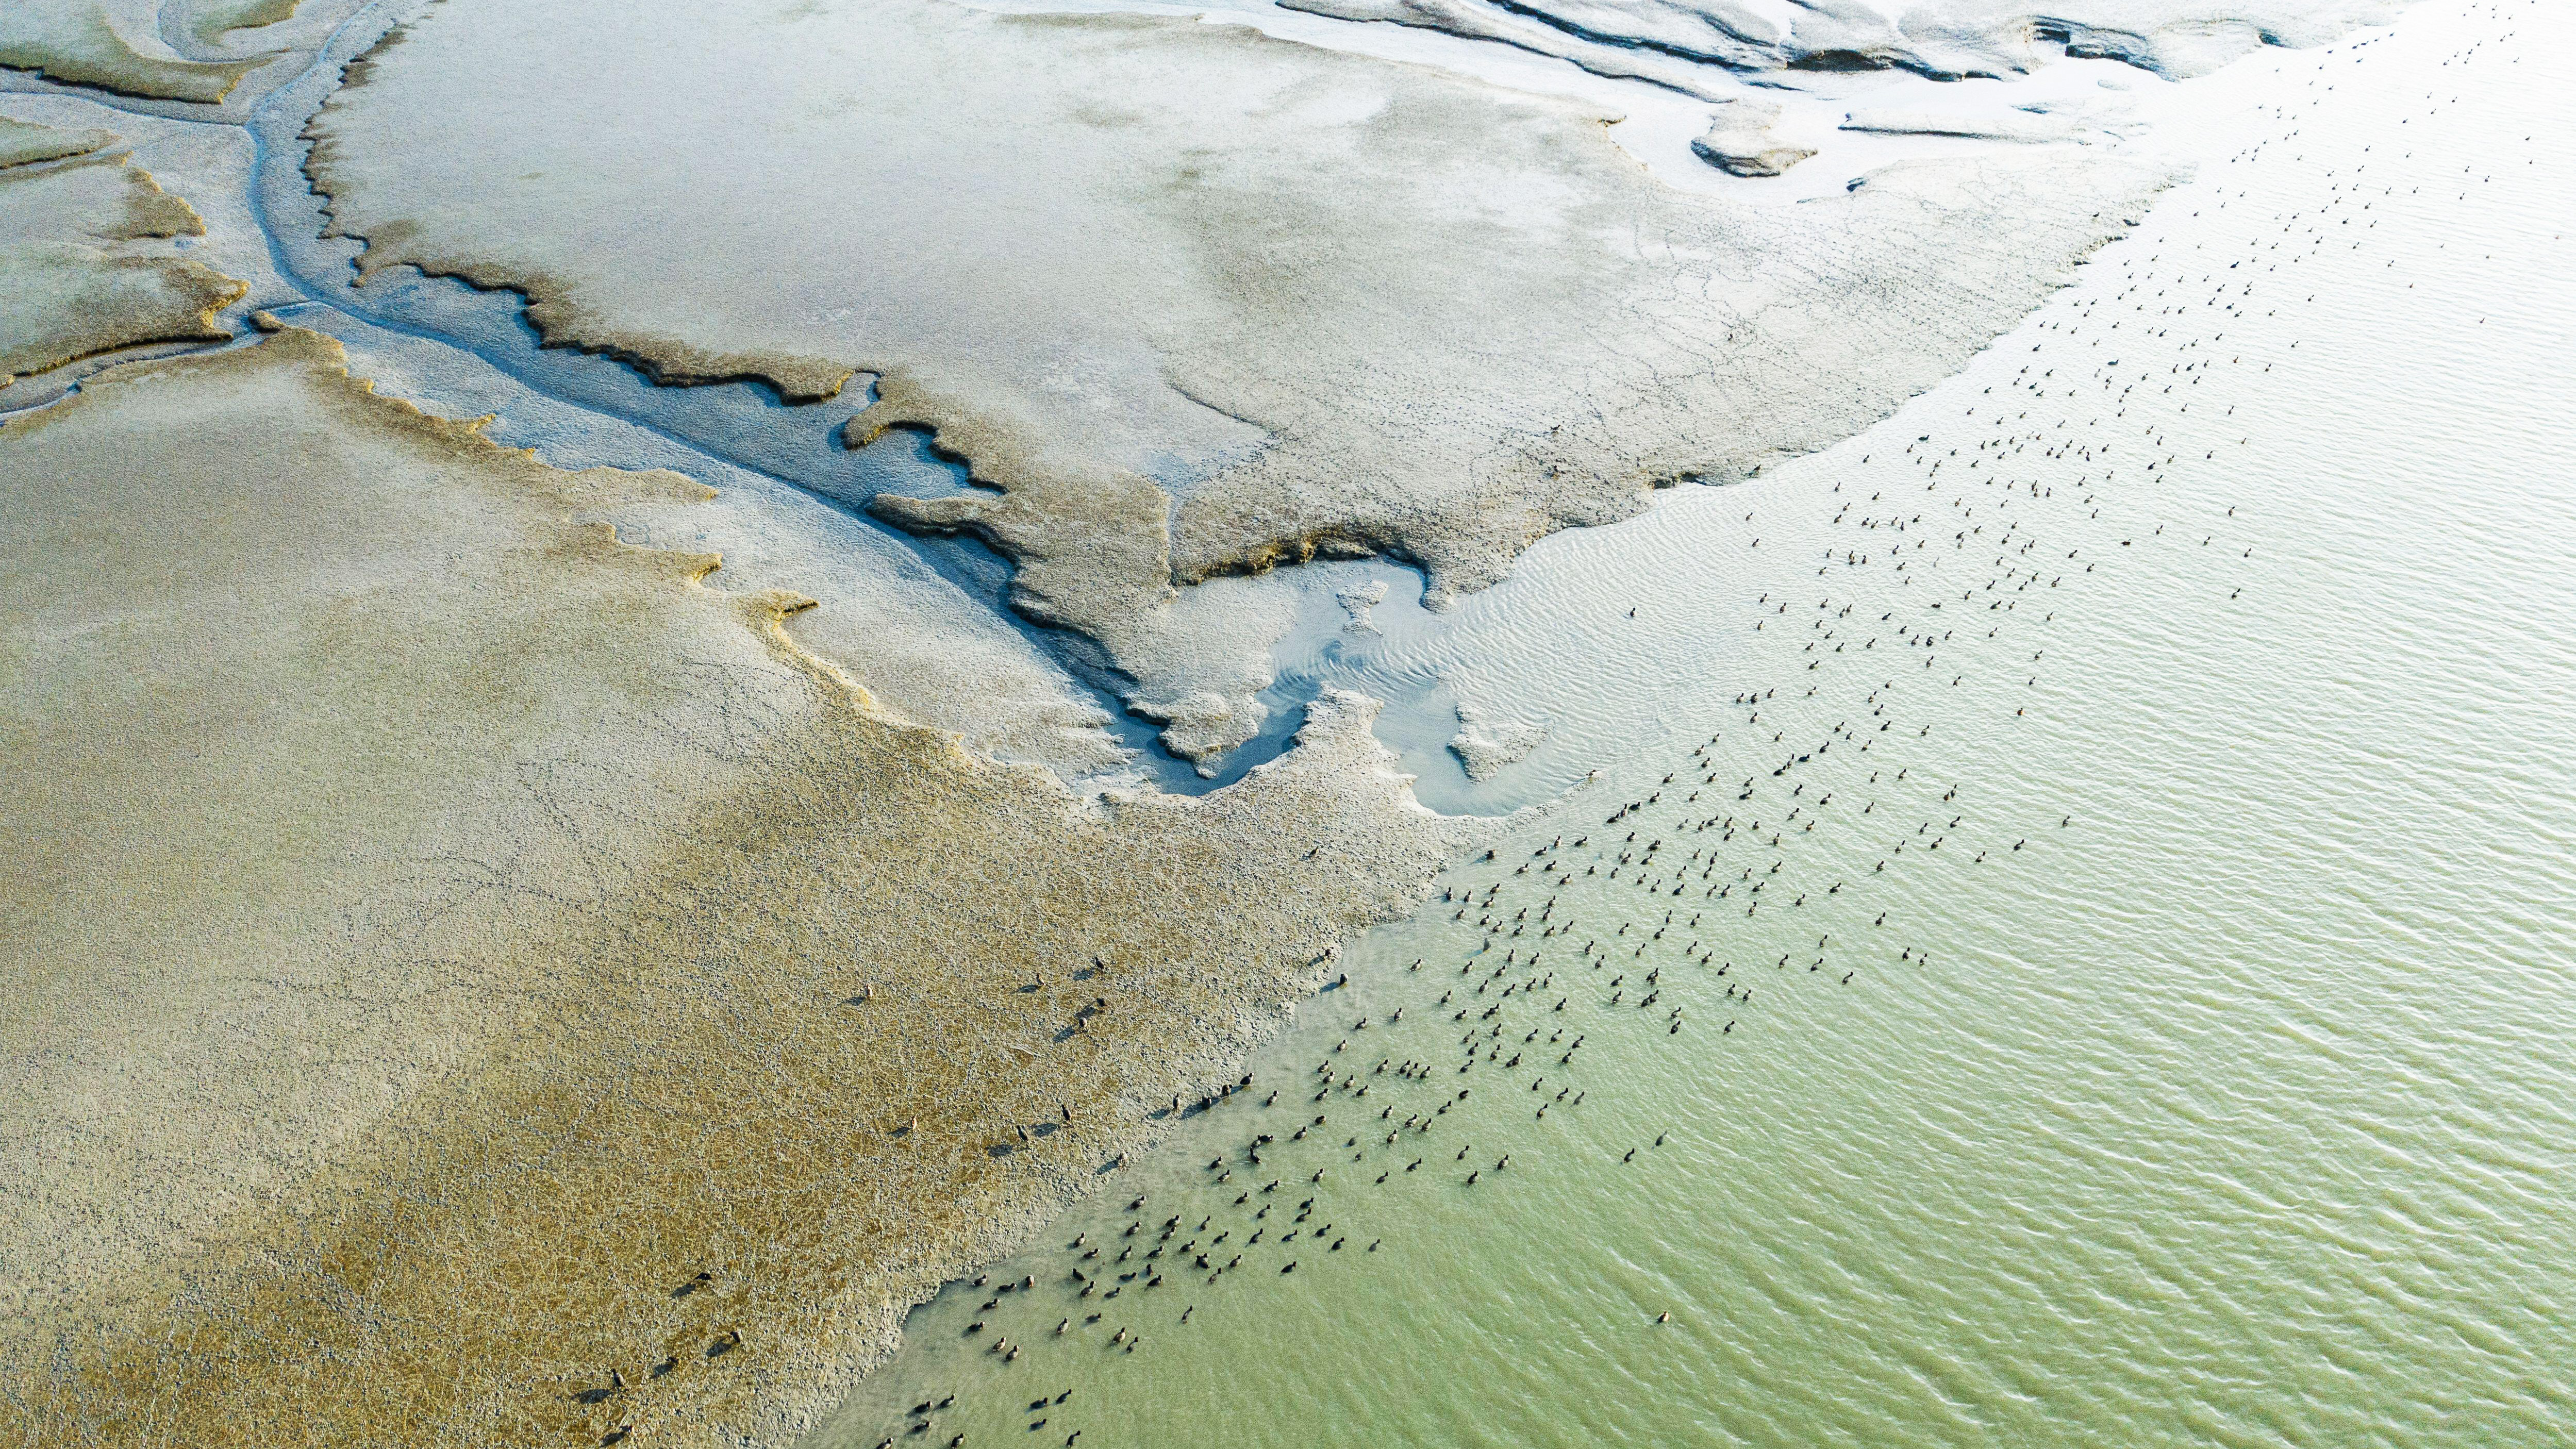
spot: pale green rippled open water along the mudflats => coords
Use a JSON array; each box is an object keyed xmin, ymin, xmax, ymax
[{"xmin": 817, "ymin": 3, "xmax": 2576, "ymax": 1446}]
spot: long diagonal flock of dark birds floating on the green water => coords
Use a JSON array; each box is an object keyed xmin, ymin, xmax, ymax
[{"xmin": 866, "ymin": 5, "xmax": 2514, "ymax": 1449}]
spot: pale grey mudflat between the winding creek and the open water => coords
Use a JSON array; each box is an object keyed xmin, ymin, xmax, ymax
[{"xmin": 309, "ymin": 0, "xmax": 2166, "ymax": 772}]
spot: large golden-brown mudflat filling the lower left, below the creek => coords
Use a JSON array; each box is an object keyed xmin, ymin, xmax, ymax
[{"xmin": 0, "ymin": 332, "xmax": 1471, "ymax": 1449}]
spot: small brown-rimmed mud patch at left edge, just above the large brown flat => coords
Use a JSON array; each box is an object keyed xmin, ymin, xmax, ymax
[{"xmin": 0, "ymin": 151, "xmax": 247, "ymax": 386}]
